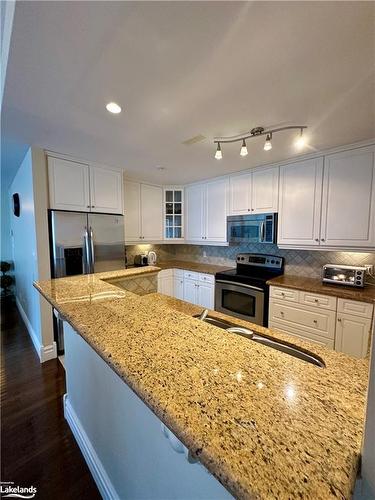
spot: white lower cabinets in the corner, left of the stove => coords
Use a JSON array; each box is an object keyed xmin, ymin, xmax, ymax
[{"xmin": 158, "ymin": 269, "xmax": 215, "ymax": 309}]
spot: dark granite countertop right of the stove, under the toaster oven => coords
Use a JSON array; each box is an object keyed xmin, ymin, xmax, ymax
[{"xmin": 267, "ymin": 274, "xmax": 375, "ymax": 303}]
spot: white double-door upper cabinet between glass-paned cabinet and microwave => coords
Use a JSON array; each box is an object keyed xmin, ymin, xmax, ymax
[{"xmin": 185, "ymin": 178, "xmax": 228, "ymax": 244}]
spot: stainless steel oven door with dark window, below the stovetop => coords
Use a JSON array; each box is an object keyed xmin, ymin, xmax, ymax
[{"xmin": 215, "ymin": 279, "xmax": 265, "ymax": 325}]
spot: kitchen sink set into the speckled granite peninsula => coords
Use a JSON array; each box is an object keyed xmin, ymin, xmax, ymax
[{"xmin": 194, "ymin": 309, "xmax": 325, "ymax": 368}]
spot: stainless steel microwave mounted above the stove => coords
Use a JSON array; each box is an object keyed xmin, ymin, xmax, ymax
[{"xmin": 227, "ymin": 214, "xmax": 277, "ymax": 243}]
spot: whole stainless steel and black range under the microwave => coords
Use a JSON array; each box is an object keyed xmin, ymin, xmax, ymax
[{"xmin": 215, "ymin": 253, "xmax": 284, "ymax": 326}]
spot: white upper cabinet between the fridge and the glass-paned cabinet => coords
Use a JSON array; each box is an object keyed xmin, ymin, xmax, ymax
[{"xmin": 124, "ymin": 181, "xmax": 163, "ymax": 243}]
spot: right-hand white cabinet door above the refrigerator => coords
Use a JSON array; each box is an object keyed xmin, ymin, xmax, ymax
[{"xmin": 90, "ymin": 167, "xmax": 124, "ymax": 214}]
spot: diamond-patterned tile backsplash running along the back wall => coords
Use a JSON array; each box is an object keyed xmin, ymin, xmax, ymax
[{"xmin": 126, "ymin": 244, "xmax": 375, "ymax": 278}]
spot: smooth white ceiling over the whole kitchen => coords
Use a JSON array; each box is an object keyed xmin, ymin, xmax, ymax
[{"xmin": 2, "ymin": 1, "xmax": 375, "ymax": 183}]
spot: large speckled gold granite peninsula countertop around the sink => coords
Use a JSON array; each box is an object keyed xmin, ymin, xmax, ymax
[{"xmin": 35, "ymin": 267, "xmax": 368, "ymax": 500}]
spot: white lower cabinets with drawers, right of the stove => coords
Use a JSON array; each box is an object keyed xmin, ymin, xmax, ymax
[{"xmin": 269, "ymin": 286, "xmax": 373, "ymax": 358}]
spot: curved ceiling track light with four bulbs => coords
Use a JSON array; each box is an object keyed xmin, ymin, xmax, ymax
[{"xmin": 214, "ymin": 125, "xmax": 307, "ymax": 160}]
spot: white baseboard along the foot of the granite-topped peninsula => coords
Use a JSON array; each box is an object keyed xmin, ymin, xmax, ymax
[{"xmin": 63, "ymin": 394, "xmax": 119, "ymax": 500}]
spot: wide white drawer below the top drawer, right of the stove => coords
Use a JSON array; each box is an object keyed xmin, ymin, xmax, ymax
[{"xmin": 270, "ymin": 300, "xmax": 336, "ymax": 340}]
